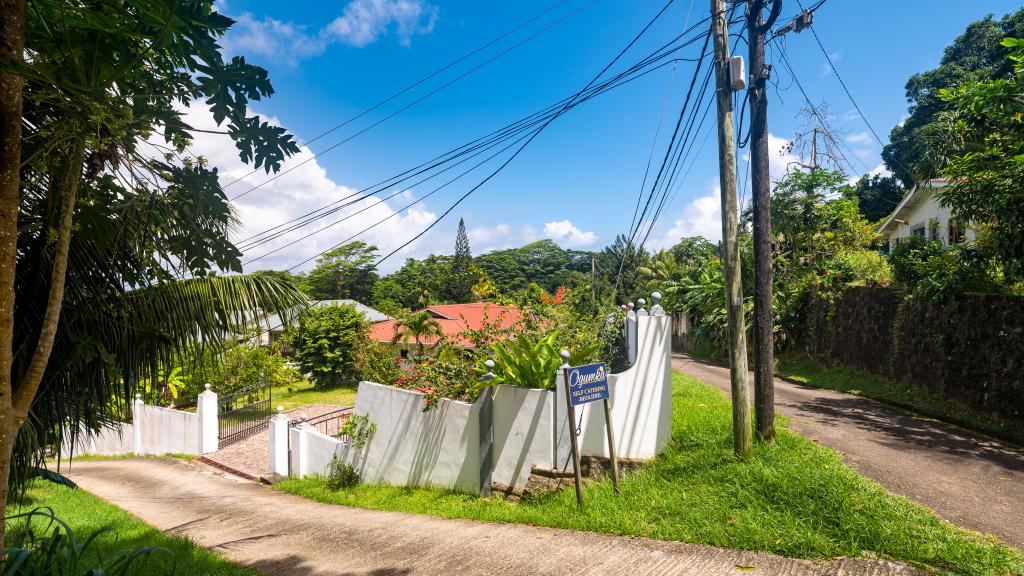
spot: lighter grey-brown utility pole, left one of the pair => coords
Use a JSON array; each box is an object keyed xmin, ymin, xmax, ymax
[{"xmin": 711, "ymin": 0, "xmax": 753, "ymax": 458}]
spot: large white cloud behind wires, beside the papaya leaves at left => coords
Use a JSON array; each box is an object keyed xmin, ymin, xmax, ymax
[{"xmin": 171, "ymin": 102, "xmax": 440, "ymax": 273}]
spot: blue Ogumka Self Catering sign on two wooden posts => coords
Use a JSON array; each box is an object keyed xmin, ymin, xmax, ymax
[{"xmin": 562, "ymin": 351, "xmax": 618, "ymax": 506}]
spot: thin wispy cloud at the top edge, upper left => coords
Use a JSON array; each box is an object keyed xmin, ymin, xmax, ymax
[{"xmin": 221, "ymin": 0, "xmax": 438, "ymax": 65}]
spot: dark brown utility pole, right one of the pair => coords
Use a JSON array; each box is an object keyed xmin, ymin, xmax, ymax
[{"xmin": 746, "ymin": 0, "xmax": 782, "ymax": 442}]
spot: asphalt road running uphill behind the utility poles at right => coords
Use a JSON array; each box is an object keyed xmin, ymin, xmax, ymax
[{"xmin": 672, "ymin": 355, "xmax": 1024, "ymax": 549}]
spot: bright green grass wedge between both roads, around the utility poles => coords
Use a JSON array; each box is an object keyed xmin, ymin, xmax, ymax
[{"xmin": 275, "ymin": 372, "xmax": 1024, "ymax": 575}]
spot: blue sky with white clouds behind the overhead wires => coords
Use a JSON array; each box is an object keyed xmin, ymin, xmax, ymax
[{"xmin": 186, "ymin": 0, "xmax": 1022, "ymax": 273}]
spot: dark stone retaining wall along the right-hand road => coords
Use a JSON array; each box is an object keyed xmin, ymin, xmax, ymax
[{"xmin": 805, "ymin": 287, "xmax": 1024, "ymax": 423}]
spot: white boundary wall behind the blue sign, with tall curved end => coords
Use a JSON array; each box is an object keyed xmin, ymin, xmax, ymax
[{"xmin": 278, "ymin": 297, "xmax": 672, "ymax": 493}]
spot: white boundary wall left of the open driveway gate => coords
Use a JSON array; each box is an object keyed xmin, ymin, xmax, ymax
[{"xmin": 61, "ymin": 387, "xmax": 217, "ymax": 457}]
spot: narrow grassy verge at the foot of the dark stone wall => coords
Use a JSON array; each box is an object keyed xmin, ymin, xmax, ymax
[{"xmin": 775, "ymin": 355, "xmax": 1024, "ymax": 446}]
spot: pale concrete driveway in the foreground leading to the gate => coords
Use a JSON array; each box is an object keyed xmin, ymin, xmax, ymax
[{"xmin": 71, "ymin": 458, "xmax": 915, "ymax": 576}]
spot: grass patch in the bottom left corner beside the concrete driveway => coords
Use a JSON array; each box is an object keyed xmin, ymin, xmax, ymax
[{"xmin": 9, "ymin": 481, "xmax": 259, "ymax": 576}]
